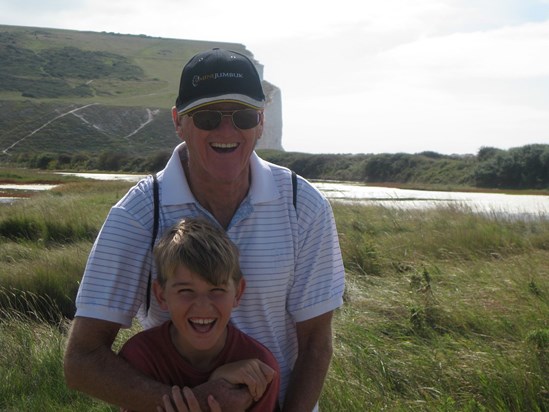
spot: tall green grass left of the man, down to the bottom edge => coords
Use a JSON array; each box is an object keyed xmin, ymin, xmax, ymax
[{"xmin": 0, "ymin": 176, "xmax": 139, "ymax": 412}]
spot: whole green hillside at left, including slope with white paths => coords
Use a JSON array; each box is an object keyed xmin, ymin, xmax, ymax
[{"xmin": 0, "ymin": 25, "xmax": 252, "ymax": 158}]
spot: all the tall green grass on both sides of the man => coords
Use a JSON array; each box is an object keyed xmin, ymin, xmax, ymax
[{"xmin": 0, "ymin": 170, "xmax": 549, "ymax": 412}]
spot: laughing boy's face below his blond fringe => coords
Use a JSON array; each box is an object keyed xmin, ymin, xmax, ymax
[{"xmin": 154, "ymin": 265, "xmax": 245, "ymax": 363}]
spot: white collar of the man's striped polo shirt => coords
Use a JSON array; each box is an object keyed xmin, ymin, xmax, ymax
[{"xmin": 157, "ymin": 143, "xmax": 280, "ymax": 206}]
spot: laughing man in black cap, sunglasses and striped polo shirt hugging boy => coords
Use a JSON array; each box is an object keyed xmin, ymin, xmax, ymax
[{"xmin": 65, "ymin": 49, "xmax": 344, "ymax": 411}]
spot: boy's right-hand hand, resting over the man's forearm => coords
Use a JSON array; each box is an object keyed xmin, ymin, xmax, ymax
[{"xmin": 208, "ymin": 359, "xmax": 276, "ymax": 401}]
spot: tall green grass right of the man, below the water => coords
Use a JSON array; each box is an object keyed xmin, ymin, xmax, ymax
[{"xmin": 321, "ymin": 205, "xmax": 549, "ymax": 411}]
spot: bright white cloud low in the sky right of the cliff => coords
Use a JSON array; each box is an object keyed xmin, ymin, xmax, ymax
[{"xmin": 276, "ymin": 14, "xmax": 549, "ymax": 153}]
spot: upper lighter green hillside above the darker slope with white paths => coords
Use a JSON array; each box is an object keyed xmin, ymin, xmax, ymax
[{"xmin": 0, "ymin": 25, "xmax": 251, "ymax": 108}]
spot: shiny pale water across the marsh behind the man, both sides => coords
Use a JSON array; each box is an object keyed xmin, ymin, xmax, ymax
[{"xmin": 4, "ymin": 173, "xmax": 549, "ymax": 218}]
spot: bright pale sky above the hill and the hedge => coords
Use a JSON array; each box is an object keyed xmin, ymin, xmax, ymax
[{"xmin": 0, "ymin": 0, "xmax": 549, "ymax": 154}]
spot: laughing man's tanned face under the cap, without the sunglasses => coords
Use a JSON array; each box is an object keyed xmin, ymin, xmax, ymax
[{"xmin": 176, "ymin": 103, "xmax": 263, "ymax": 182}]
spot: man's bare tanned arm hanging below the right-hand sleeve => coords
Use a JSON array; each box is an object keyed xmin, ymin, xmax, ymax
[{"xmin": 282, "ymin": 312, "xmax": 333, "ymax": 412}]
